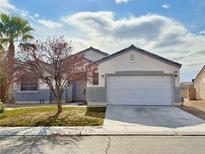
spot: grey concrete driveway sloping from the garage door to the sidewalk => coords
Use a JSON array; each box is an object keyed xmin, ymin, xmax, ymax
[{"xmin": 104, "ymin": 106, "xmax": 205, "ymax": 128}]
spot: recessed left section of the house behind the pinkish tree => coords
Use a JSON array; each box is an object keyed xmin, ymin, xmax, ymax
[{"xmin": 14, "ymin": 47, "xmax": 108, "ymax": 103}]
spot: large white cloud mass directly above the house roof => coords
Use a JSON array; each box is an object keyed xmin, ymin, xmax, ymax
[{"xmin": 63, "ymin": 12, "xmax": 205, "ymax": 78}]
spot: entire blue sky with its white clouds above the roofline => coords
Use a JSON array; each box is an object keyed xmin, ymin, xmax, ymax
[{"xmin": 0, "ymin": 0, "xmax": 205, "ymax": 81}]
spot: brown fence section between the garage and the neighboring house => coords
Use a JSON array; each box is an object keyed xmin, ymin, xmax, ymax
[{"xmin": 180, "ymin": 82, "xmax": 196, "ymax": 101}]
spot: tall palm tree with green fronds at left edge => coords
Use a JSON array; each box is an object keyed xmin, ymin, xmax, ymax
[{"xmin": 0, "ymin": 14, "xmax": 33, "ymax": 101}]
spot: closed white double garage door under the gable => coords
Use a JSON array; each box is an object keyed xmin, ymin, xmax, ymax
[{"xmin": 107, "ymin": 76, "xmax": 172, "ymax": 105}]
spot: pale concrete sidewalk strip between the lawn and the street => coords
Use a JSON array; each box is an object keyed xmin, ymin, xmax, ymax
[{"xmin": 0, "ymin": 124, "xmax": 205, "ymax": 136}]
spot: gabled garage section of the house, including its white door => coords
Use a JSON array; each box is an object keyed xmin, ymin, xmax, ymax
[{"xmin": 86, "ymin": 45, "xmax": 181, "ymax": 106}]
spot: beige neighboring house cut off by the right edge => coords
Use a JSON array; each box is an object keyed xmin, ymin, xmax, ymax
[{"xmin": 194, "ymin": 66, "xmax": 205, "ymax": 100}]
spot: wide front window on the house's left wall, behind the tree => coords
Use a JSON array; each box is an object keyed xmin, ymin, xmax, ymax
[{"xmin": 20, "ymin": 80, "xmax": 38, "ymax": 91}]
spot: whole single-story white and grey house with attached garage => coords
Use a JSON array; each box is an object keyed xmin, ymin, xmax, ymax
[{"xmin": 15, "ymin": 45, "xmax": 181, "ymax": 106}]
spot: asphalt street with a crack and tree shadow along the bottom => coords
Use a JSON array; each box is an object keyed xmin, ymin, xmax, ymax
[{"xmin": 0, "ymin": 136, "xmax": 205, "ymax": 154}]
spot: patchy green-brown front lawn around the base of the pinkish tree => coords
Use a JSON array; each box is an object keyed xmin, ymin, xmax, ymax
[{"xmin": 0, "ymin": 106, "xmax": 106, "ymax": 127}]
